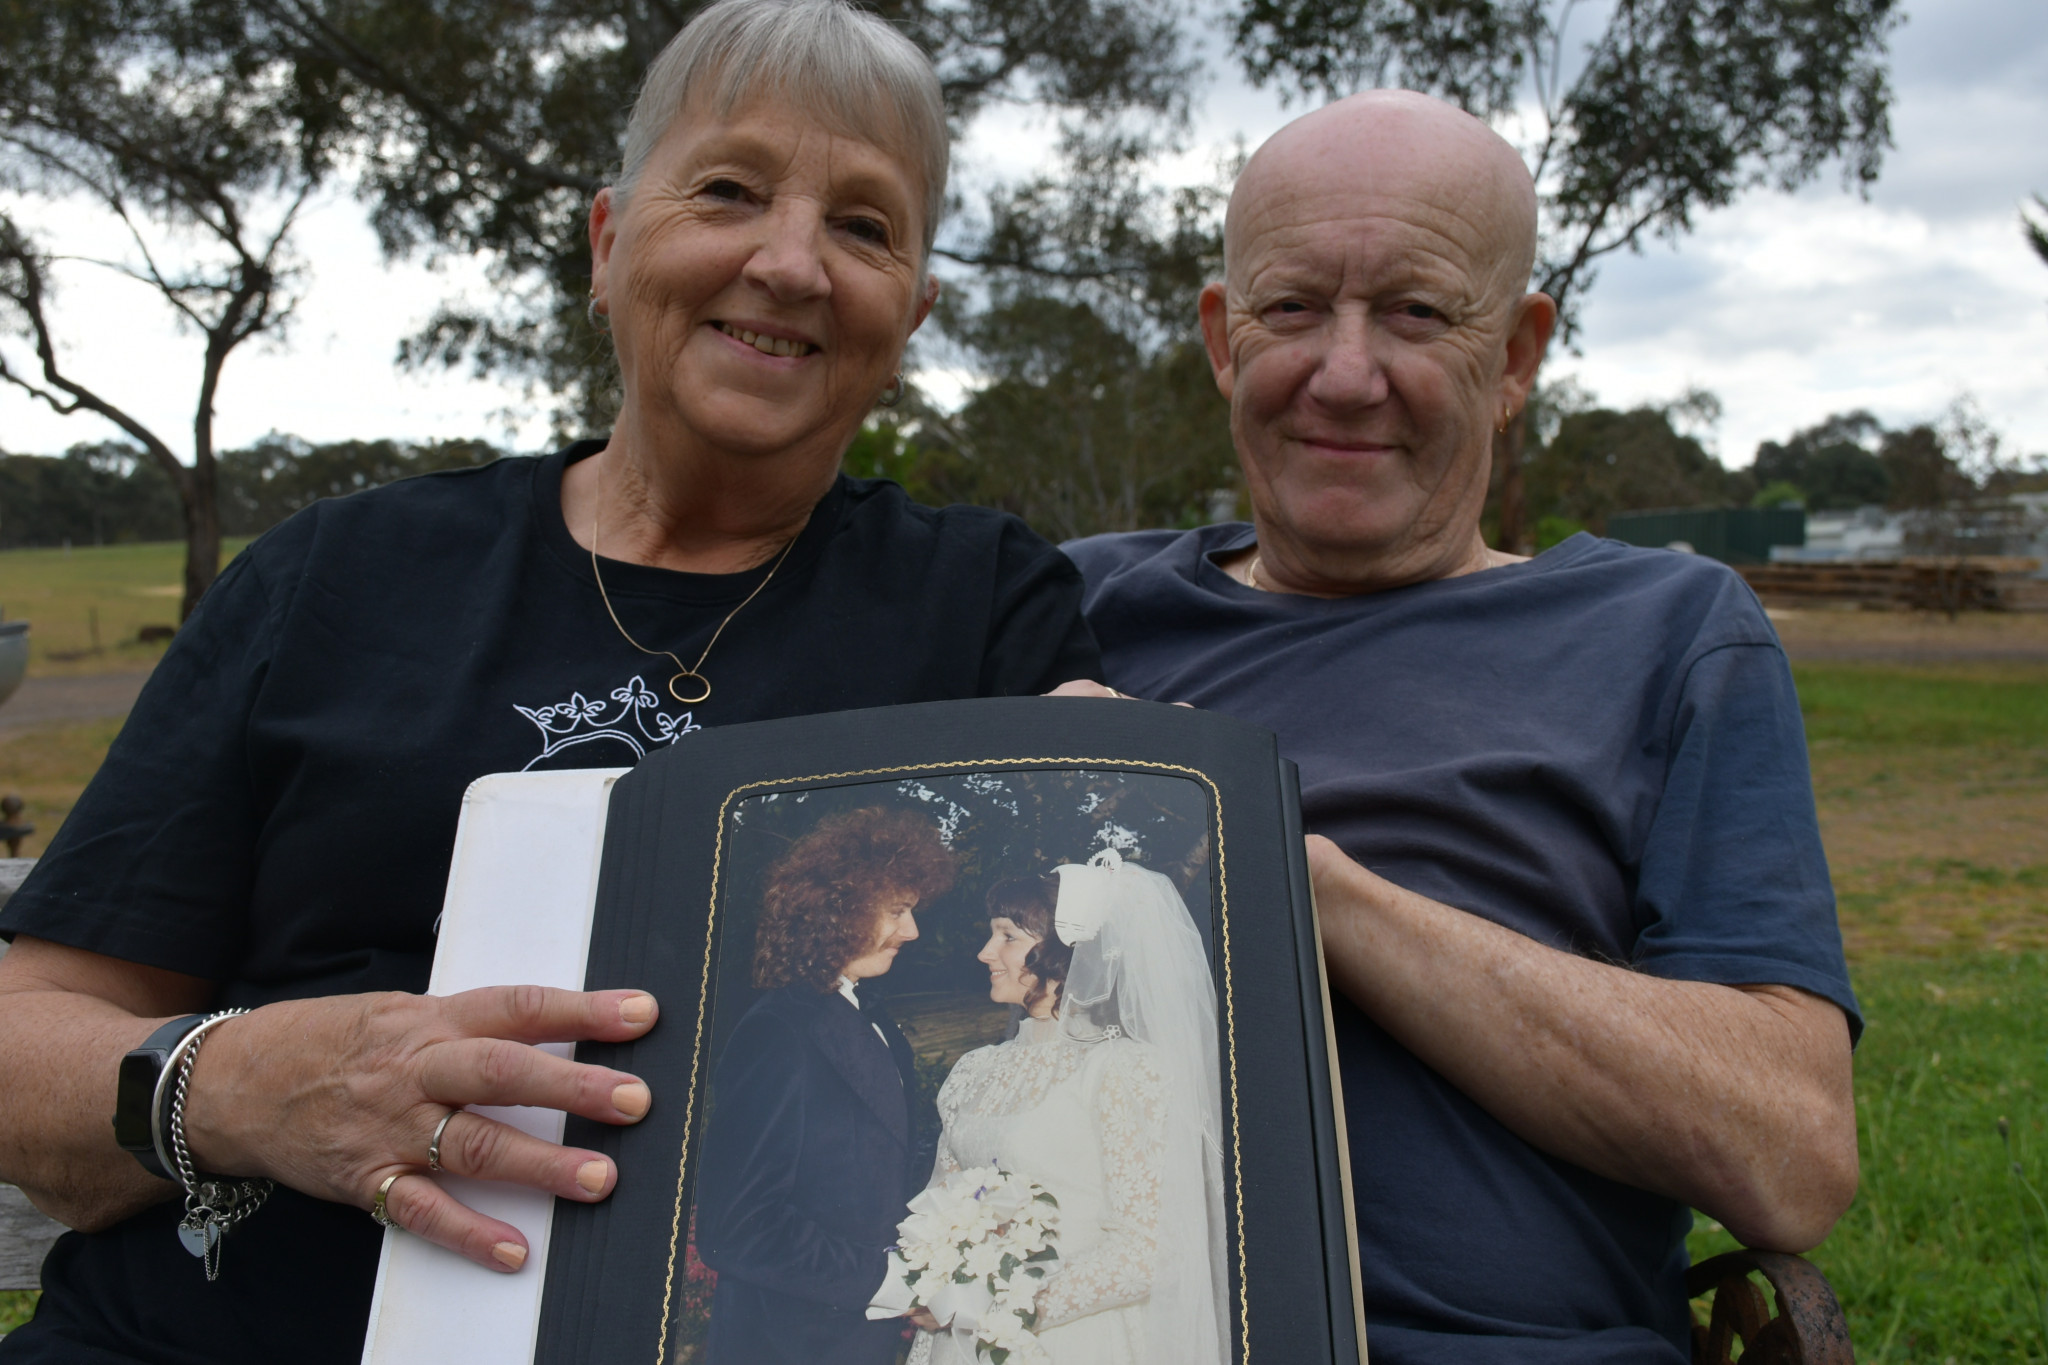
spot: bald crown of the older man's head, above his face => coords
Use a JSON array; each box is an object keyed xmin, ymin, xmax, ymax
[{"xmin": 1223, "ymin": 90, "xmax": 1536, "ymax": 301}]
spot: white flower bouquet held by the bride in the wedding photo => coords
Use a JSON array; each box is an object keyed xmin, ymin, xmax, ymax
[{"xmin": 868, "ymin": 1166, "xmax": 1059, "ymax": 1365}]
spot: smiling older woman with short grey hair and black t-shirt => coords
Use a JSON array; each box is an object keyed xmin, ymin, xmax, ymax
[{"xmin": 0, "ymin": 0, "xmax": 1096, "ymax": 1365}]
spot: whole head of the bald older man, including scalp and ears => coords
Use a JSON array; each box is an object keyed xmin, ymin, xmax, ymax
[{"xmin": 1200, "ymin": 90, "xmax": 1556, "ymax": 593}]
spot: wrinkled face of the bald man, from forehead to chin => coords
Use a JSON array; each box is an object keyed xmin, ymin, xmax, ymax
[{"xmin": 1202, "ymin": 158, "xmax": 1520, "ymax": 563}]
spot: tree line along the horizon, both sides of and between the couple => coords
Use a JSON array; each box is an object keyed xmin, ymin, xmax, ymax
[{"xmin": 0, "ymin": 388, "xmax": 2048, "ymax": 548}]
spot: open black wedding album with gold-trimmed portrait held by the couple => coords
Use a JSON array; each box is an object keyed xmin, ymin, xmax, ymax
[{"xmin": 365, "ymin": 698, "xmax": 1370, "ymax": 1365}]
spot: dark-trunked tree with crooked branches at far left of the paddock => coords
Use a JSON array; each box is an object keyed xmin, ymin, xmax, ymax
[{"xmin": 0, "ymin": 0, "xmax": 334, "ymax": 616}]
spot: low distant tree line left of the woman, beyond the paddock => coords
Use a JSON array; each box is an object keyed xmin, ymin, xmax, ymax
[{"xmin": 0, "ymin": 434, "xmax": 504, "ymax": 548}]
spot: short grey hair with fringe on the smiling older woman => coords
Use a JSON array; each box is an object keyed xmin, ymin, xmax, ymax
[{"xmin": 612, "ymin": 0, "xmax": 952, "ymax": 260}]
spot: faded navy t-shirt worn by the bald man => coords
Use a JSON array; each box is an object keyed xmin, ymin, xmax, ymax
[{"xmin": 1065, "ymin": 524, "xmax": 1860, "ymax": 1365}]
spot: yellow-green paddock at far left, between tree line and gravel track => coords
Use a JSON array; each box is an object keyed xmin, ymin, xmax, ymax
[{"xmin": 0, "ymin": 538, "xmax": 248, "ymax": 675}]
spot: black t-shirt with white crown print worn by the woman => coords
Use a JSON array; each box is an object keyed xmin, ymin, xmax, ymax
[{"xmin": 0, "ymin": 442, "xmax": 1098, "ymax": 1365}]
